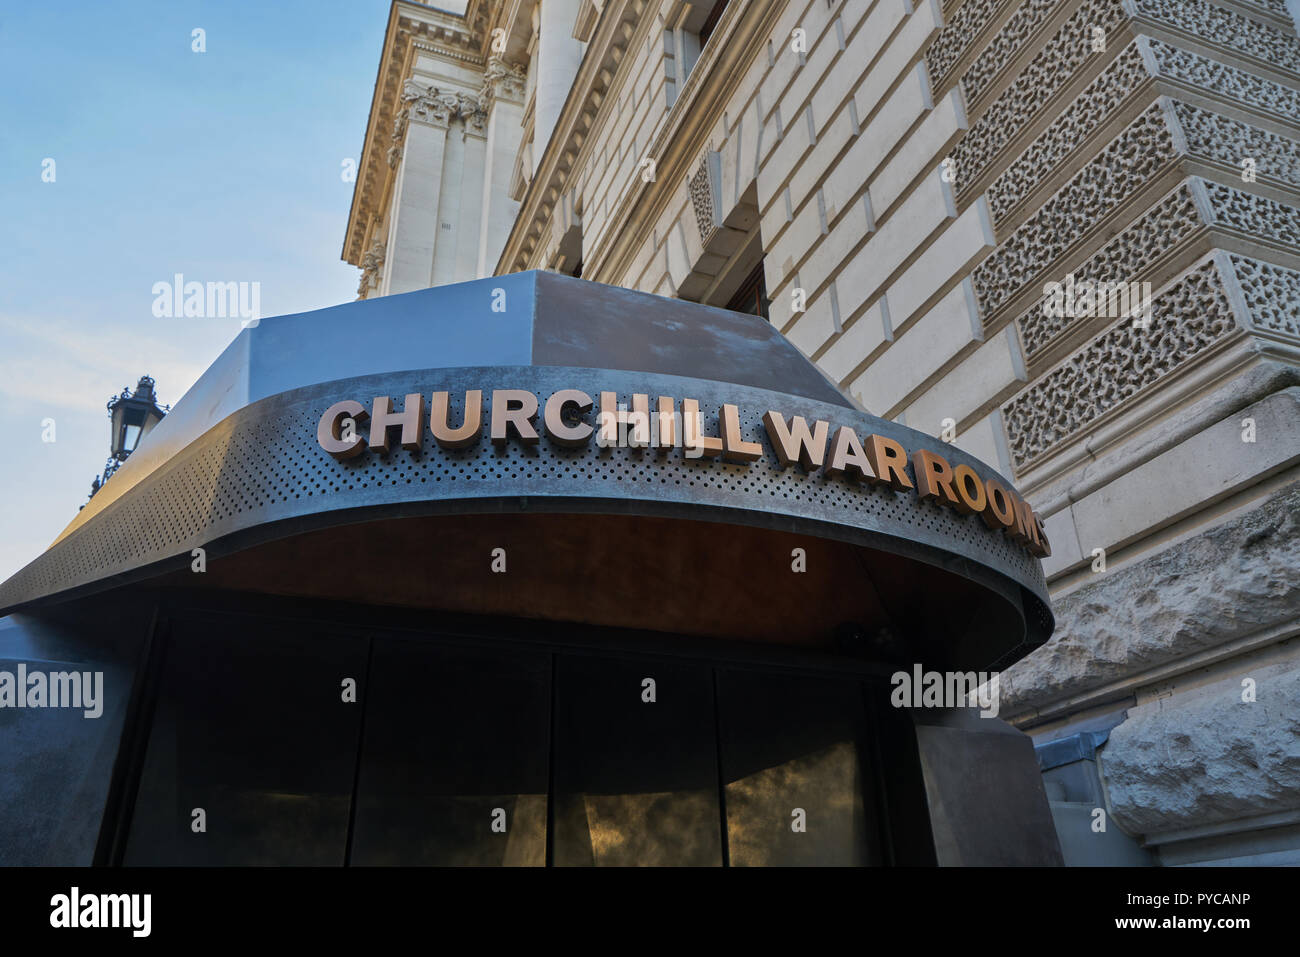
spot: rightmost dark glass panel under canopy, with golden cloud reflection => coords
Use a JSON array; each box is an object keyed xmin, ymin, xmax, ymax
[{"xmin": 718, "ymin": 671, "xmax": 880, "ymax": 866}]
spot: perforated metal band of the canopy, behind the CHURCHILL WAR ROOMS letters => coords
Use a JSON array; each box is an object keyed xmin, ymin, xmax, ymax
[{"xmin": 0, "ymin": 365, "xmax": 1052, "ymax": 644}]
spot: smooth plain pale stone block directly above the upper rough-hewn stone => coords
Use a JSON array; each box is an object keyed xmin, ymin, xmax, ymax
[{"xmin": 1074, "ymin": 387, "xmax": 1300, "ymax": 551}]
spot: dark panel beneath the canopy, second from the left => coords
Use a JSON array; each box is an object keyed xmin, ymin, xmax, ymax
[{"xmin": 351, "ymin": 638, "xmax": 551, "ymax": 866}]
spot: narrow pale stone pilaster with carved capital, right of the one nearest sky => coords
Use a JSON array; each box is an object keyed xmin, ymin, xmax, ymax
[{"xmin": 476, "ymin": 56, "xmax": 527, "ymax": 278}]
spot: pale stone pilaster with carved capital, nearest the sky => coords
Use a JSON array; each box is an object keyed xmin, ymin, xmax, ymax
[{"xmin": 384, "ymin": 83, "xmax": 456, "ymax": 295}]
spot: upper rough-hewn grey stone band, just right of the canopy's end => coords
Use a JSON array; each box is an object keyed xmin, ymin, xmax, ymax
[{"xmin": 1001, "ymin": 484, "xmax": 1300, "ymax": 716}]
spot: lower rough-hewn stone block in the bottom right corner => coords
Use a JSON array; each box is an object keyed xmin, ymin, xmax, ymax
[{"xmin": 1100, "ymin": 666, "xmax": 1300, "ymax": 833}]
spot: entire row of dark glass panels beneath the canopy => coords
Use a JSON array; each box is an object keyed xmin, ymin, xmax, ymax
[{"xmin": 124, "ymin": 615, "xmax": 894, "ymax": 866}]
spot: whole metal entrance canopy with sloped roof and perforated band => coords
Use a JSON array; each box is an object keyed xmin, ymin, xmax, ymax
[{"xmin": 0, "ymin": 273, "xmax": 1053, "ymax": 657}]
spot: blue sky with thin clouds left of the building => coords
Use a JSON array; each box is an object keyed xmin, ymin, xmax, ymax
[{"xmin": 0, "ymin": 0, "xmax": 413, "ymax": 580}]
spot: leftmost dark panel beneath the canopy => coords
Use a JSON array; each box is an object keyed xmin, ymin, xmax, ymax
[{"xmin": 125, "ymin": 622, "xmax": 367, "ymax": 866}]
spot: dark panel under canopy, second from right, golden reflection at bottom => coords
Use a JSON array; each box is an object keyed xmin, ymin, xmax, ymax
[{"xmin": 553, "ymin": 655, "xmax": 723, "ymax": 866}]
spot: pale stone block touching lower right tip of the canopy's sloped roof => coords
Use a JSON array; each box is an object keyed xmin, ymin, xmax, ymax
[{"xmin": 852, "ymin": 280, "xmax": 980, "ymax": 421}]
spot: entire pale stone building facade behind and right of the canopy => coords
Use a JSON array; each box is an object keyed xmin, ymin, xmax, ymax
[{"xmin": 343, "ymin": 0, "xmax": 1300, "ymax": 865}]
